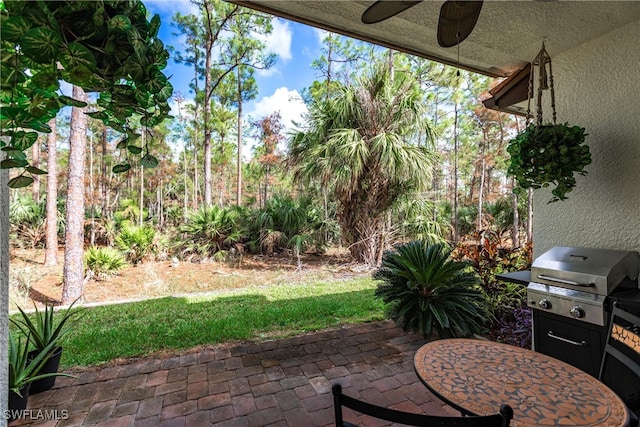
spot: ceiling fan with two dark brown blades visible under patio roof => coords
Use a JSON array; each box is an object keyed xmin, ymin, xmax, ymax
[{"xmin": 362, "ymin": 0, "xmax": 482, "ymax": 47}]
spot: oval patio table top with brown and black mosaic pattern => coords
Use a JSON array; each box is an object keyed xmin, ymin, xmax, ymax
[{"xmin": 414, "ymin": 338, "xmax": 630, "ymax": 427}]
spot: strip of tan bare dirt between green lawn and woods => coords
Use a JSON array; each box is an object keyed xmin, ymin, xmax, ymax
[{"xmin": 9, "ymin": 249, "xmax": 370, "ymax": 308}]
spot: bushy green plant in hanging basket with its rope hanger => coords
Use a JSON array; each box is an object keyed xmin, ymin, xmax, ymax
[{"xmin": 507, "ymin": 43, "xmax": 591, "ymax": 203}]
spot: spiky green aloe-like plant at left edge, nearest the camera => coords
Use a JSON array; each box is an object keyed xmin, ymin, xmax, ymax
[{"xmin": 8, "ymin": 334, "xmax": 73, "ymax": 421}]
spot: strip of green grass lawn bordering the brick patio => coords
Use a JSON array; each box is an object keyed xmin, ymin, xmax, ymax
[{"xmin": 20, "ymin": 278, "xmax": 384, "ymax": 369}]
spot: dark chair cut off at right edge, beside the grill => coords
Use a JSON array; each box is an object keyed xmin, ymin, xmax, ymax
[{"xmin": 598, "ymin": 301, "xmax": 640, "ymax": 426}]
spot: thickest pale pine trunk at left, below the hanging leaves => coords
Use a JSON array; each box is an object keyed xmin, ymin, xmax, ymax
[{"xmin": 62, "ymin": 86, "xmax": 87, "ymax": 304}]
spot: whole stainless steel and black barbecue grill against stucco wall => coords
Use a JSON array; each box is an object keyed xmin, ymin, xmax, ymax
[{"xmin": 527, "ymin": 247, "xmax": 640, "ymax": 382}]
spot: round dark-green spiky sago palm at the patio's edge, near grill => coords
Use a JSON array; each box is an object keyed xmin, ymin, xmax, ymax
[{"xmin": 373, "ymin": 240, "xmax": 488, "ymax": 338}]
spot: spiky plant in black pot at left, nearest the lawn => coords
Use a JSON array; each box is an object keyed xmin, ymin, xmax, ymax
[{"xmin": 11, "ymin": 300, "xmax": 81, "ymax": 394}]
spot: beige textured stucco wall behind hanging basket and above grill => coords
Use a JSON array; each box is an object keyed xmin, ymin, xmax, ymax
[{"xmin": 533, "ymin": 21, "xmax": 640, "ymax": 257}]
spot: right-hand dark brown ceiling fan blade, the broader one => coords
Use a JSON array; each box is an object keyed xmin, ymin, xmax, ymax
[{"xmin": 438, "ymin": 0, "xmax": 482, "ymax": 47}]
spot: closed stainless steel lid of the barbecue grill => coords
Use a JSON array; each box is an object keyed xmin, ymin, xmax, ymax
[{"xmin": 531, "ymin": 246, "xmax": 640, "ymax": 295}]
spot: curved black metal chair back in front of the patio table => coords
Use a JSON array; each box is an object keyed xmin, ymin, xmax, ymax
[{"xmin": 332, "ymin": 384, "xmax": 513, "ymax": 427}]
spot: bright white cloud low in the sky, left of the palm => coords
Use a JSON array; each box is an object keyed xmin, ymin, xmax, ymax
[{"xmin": 249, "ymin": 87, "xmax": 307, "ymax": 133}]
